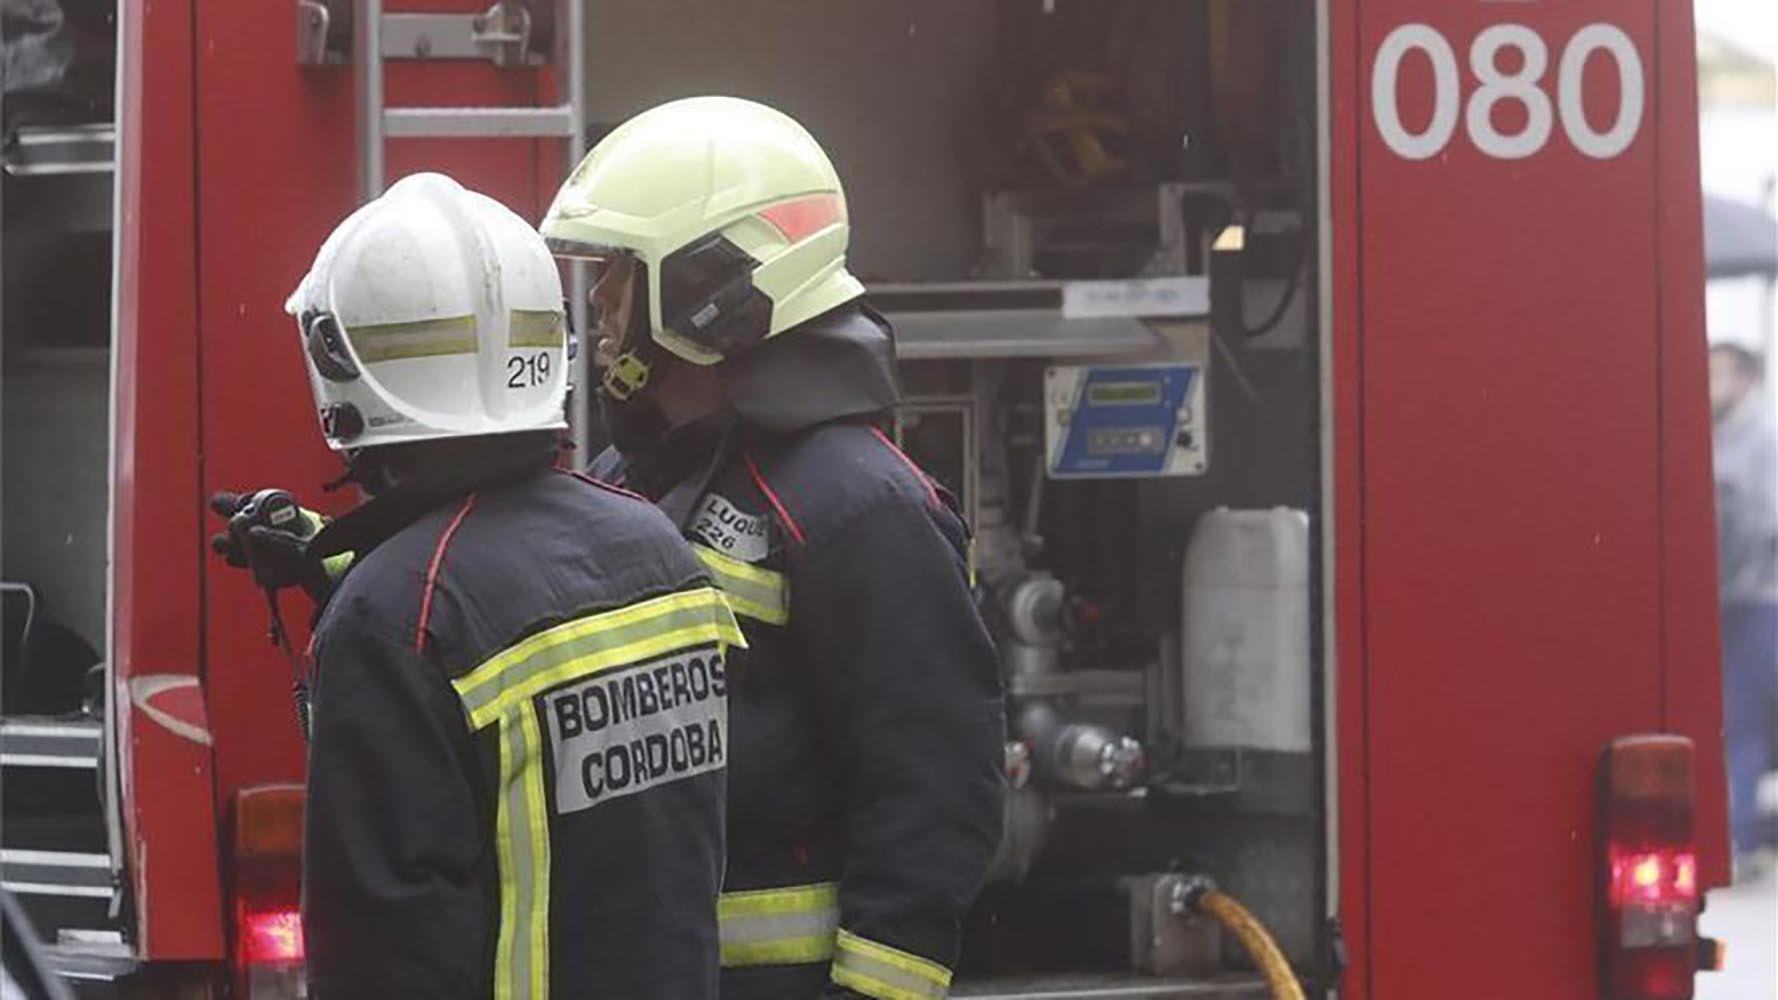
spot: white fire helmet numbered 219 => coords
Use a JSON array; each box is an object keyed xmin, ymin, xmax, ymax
[{"xmin": 284, "ymin": 174, "xmax": 567, "ymax": 450}]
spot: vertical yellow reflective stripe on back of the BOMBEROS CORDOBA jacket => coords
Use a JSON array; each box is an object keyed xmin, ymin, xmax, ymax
[{"xmin": 494, "ymin": 705, "xmax": 549, "ymax": 1000}]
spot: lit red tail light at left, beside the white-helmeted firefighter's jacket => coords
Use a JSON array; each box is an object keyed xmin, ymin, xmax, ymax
[{"xmin": 229, "ymin": 785, "xmax": 308, "ymax": 1000}]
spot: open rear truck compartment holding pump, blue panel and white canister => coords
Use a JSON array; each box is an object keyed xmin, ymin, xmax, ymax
[{"xmin": 587, "ymin": 0, "xmax": 1337, "ymax": 996}]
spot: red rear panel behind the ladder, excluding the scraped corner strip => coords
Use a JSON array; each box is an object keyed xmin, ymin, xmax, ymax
[{"xmin": 197, "ymin": 2, "xmax": 562, "ymax": 818}]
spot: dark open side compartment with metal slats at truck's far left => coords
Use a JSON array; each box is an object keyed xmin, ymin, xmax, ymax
[{"xmin": 0, "ymin": 0, "xmax": 126, "ymax": 970}]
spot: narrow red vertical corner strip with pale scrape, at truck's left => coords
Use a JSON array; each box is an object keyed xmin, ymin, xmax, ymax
[{"xmin": 112, "ymin": 0, "xmax": 222, "ymax": 959}]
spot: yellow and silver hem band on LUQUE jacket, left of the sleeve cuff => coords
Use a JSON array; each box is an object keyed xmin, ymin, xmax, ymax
[{"xmin": 717, "ymin": 883, "xmax": 839, "ymax": 968}]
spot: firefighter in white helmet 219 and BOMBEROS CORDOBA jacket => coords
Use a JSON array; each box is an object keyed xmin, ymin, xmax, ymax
[{"xmin": 216, "ymin": 174, "xmax": 741, "ymax": 1000}]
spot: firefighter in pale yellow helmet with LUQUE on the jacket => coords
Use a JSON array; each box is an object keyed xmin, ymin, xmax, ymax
[{"xmin": 542, "ymin": 98, "xmax": 1003, "ymax": 1000}]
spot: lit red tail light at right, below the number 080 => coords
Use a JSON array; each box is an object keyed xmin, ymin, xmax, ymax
[{"xmin": 1598, "ymin": 735, "xmax": 1703, "ymax": 1000}]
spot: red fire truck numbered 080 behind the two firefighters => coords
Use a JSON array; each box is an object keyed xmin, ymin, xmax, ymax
[{"xmin": 0, "ymin": 0, "xmax": 1728, "ymax": 1000}]
